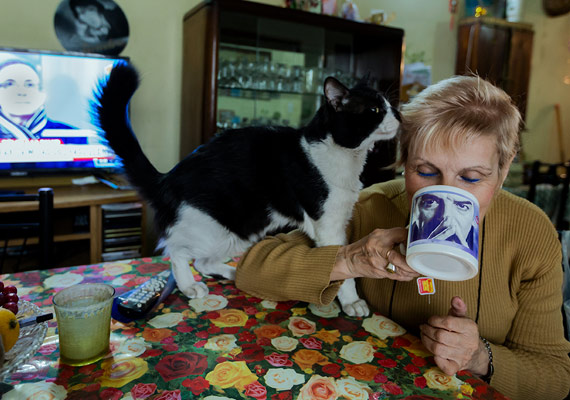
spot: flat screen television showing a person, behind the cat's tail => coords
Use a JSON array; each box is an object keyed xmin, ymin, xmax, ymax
[{"xmin": 0, "ymin": 48, "xmax": 125, "ymax": 176}]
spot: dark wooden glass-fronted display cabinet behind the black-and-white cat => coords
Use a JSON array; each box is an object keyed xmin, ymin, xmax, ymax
[{"xmin": 180, "ymin": 0, "xmax": 404, "ymax": 185}]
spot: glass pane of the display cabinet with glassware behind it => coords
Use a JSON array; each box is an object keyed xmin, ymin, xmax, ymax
[{"xmin": 216, "ymin": 12, "xmax": 354, "ymax": 130}]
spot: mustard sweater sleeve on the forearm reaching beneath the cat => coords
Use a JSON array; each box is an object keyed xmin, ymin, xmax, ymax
[{"xmin": 236, "ymin": 231, "xmax": 341, "ymax": 304}]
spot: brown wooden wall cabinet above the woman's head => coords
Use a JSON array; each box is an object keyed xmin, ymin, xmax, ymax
[{"xmin": 455, "ymin": 17, "xmax": 534, "ymax": 120}]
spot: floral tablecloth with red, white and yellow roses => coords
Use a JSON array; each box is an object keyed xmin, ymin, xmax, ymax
[{"xmin": 1, "ymin": 257, "xmax": 504, "ymax": 400}]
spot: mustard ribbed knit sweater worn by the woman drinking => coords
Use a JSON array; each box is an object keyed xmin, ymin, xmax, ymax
[{"xmin": 236, "ymin": 180, "xmax": 570, "ymax": 400}]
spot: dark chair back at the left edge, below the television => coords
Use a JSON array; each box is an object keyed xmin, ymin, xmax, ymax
[{"xmin": 0, "ymin": 188, "xmax": 53, "ymax": 271}]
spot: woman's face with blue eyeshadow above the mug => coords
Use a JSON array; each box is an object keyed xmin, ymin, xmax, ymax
[{"xmin": 405, "ymin": 136, "xmax": 510, "ymax": 218}]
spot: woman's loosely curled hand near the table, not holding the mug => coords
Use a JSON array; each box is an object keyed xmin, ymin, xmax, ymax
[{"xmin": 420, "ymin": 296, "xmax": 489, "ymax": 376}]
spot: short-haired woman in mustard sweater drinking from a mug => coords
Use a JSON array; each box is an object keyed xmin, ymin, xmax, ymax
[{"xmin": 236, "ymin": 77, "xmax": 570, "ymax": 399}]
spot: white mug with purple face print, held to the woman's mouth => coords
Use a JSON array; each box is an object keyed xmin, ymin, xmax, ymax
[{"xmin": 406, "ymin": 185, "xmax": 479, "ymax": 281}]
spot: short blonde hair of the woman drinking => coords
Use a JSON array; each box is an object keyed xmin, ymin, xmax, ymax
[{"xmin": 398, "ymin": 76, "xmax": 521, "ymax": 170}]
